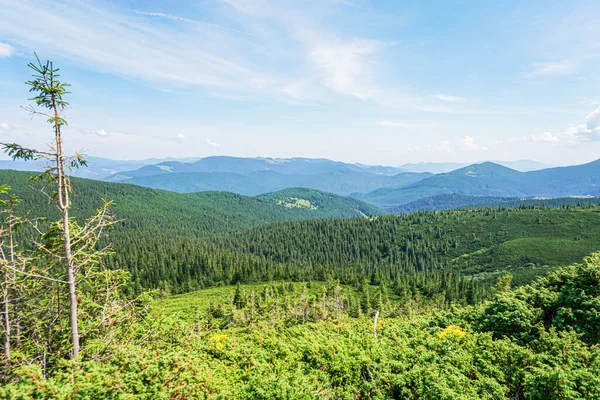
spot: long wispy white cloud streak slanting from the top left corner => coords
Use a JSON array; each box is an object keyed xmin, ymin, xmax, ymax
[{"xmin": 0, "ymin": 0, "xmax": 272, "ymax": 91}]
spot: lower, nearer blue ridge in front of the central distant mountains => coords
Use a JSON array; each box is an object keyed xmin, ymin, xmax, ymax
[{"xmin": 124, "ymin": 167, "xmax": 431, "ymax": 196}]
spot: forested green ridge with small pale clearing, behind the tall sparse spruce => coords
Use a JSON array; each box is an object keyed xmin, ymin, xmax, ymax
[{"xmin": 0, "ymin": 170, "xmax": 381, "ymax": 237}]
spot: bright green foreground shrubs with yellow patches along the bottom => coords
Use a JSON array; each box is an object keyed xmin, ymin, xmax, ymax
[{"xmin": 0, "ymin": 254, "xmax": 600, "ymax": 399}]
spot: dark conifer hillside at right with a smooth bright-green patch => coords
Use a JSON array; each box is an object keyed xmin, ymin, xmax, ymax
[{"xmin": 214, "ymin": 205, "xmax": 600, "ymax": 283}]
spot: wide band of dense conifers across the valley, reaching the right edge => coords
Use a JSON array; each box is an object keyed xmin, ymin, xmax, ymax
[{"xmin": 89, "ymin": 202, "xmax": 600, "ymax": 293}]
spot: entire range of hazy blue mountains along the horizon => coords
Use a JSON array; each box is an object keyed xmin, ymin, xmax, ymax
[{"xmin": 0, "ymin": 156, "xmax": 600, "ymax": 212}]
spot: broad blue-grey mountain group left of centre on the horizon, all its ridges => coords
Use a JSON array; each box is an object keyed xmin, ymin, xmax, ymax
[{"xmin": 107, "ymin": 156, "xmax": 432, "ymax": 195}]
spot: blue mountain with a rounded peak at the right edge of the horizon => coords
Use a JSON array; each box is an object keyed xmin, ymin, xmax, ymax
[{"xmin": 356, "ymin": 160, "xmax": 600, "ymax": 208}]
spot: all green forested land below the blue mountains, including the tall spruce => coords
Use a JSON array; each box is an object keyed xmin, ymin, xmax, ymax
[{"xmin": 0, "ymin": 54, "xmax": 600, "ymax": 399}]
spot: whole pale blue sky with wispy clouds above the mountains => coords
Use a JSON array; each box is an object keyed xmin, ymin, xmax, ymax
[{"xmin": 0, "ymin": 0, "xmax": 600, "ymax": 165}]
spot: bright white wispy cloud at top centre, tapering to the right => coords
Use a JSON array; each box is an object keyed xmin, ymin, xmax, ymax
[{"xmin": 220, "ymin": 0, "xmax": 460, "ymax": 113}]
